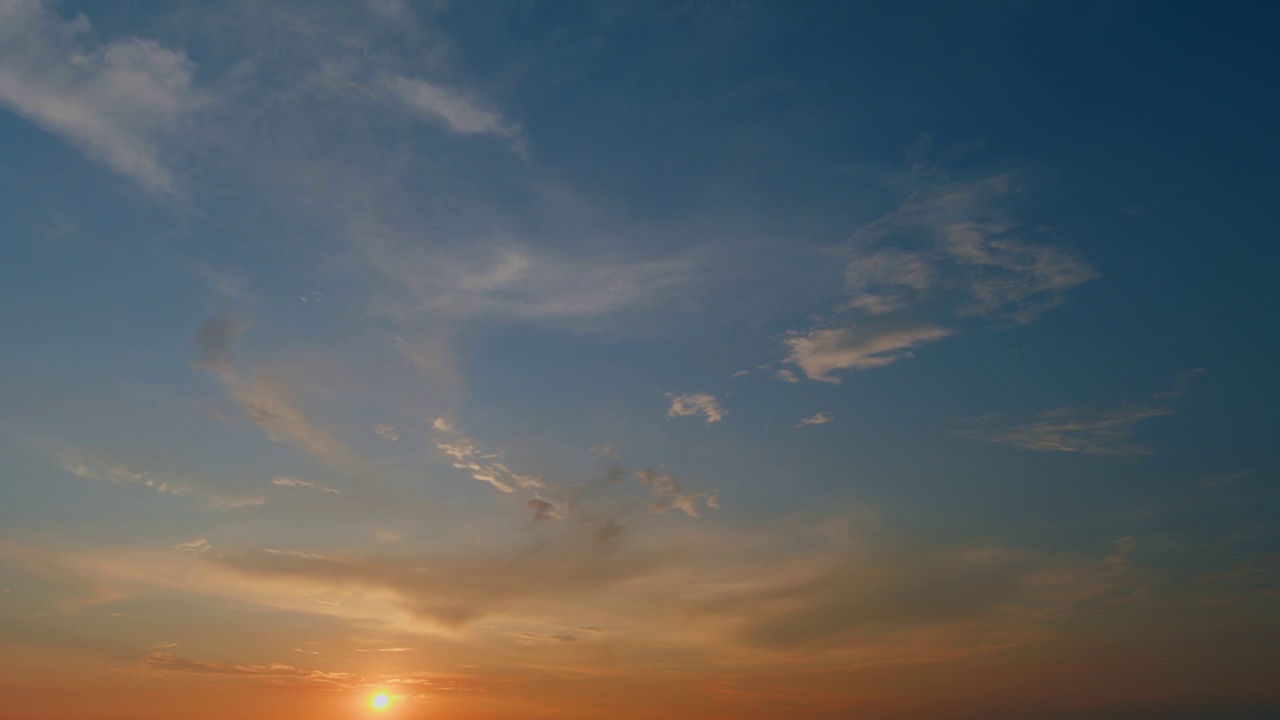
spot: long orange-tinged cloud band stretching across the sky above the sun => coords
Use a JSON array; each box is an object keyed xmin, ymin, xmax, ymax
[{"xmin": 0, "ymin": 507, "xmax": 1143, "ymax": 674}]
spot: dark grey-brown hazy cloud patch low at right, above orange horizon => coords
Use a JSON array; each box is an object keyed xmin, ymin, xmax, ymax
[{"xmin": 699, "ymin": 544, "xmax": 1129, "ymax": 650}]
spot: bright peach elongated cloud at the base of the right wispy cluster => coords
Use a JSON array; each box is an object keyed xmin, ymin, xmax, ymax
[{"xmin": 785, "ymin": 325, "xmax": 952, "ymax": 383}]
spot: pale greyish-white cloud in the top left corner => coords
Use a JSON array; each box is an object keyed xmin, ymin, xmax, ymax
[{"xmin": 0, "ymin": 0, "xmax": 206, "ymax": 193}]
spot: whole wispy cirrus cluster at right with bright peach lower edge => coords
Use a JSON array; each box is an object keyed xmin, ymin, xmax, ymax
[{"xmin": 783, "ymin": 157, "xmax": 1097, "ymax": 383}]
